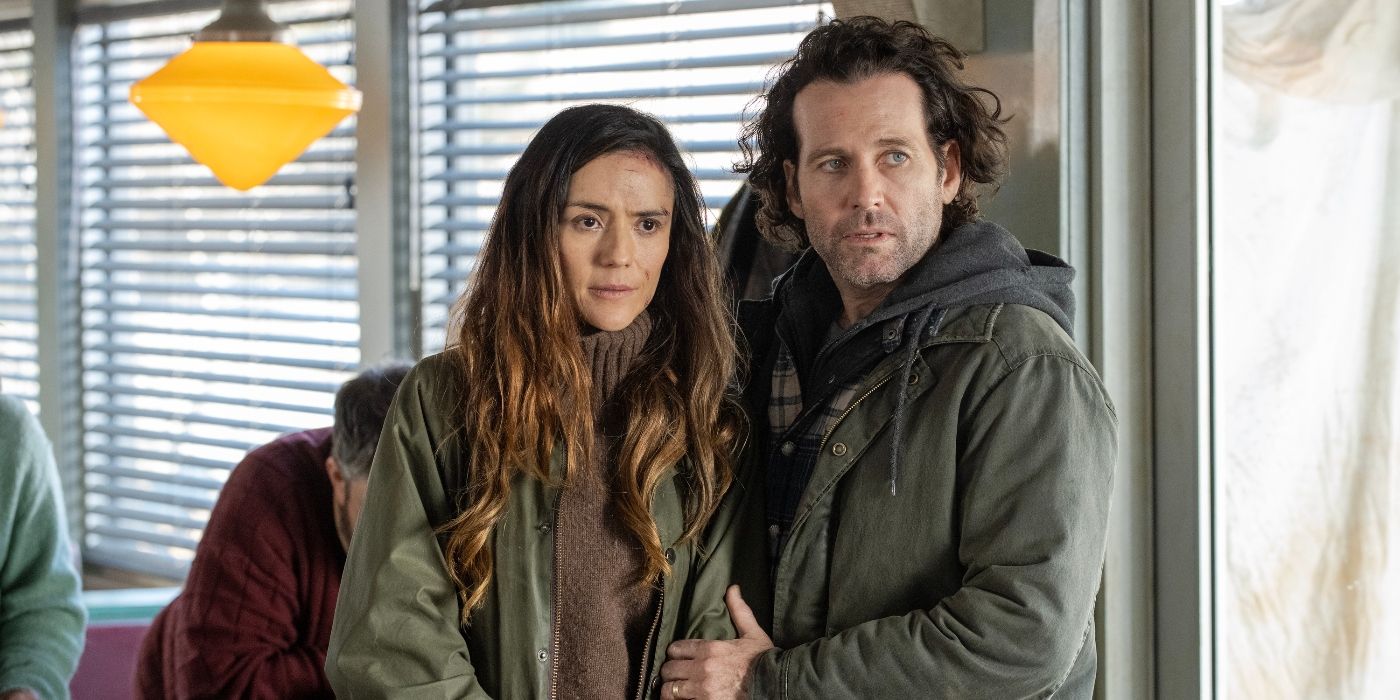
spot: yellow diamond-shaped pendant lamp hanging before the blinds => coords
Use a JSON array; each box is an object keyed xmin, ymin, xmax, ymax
[{"xmin": 130, "ymin": 0, "xmax": 361, "ymax": 190}]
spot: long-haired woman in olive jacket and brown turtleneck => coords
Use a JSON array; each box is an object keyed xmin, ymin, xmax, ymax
[{"xmin": 326, "ymin": 105, "xmax": 766, "ymax": 697}]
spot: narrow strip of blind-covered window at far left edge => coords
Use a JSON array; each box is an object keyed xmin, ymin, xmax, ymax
[{"xmin": 0, "ymin": 22, "xmax": 39, "ymax": 412}]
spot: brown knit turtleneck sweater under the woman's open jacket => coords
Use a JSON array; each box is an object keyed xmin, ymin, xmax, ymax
[{"xmin": 554, "ymin": 311, "xmax": 657, "ymax": 700}]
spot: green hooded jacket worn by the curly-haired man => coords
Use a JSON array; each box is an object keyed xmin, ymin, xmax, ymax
[{"xmin": 741, "ymin": 224, "xmax": 1116, "ymax": 700}]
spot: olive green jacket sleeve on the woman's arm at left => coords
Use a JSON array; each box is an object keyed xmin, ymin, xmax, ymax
[{"xmin": 326, "ymin": 364, "xmax": 489, "ymax": 699}]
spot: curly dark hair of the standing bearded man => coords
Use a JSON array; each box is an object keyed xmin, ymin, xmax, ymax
[{"xmin": 735, "ymin": 17, "xmax": 1007, "ymax": 251}]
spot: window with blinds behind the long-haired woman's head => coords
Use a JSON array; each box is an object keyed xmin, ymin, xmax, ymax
[{"xmin": 417, "ymin": 0, "xmax": 832, "ymax": 351}]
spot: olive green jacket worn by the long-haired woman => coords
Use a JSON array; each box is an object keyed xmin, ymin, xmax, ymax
[{"xmin": 326, "ymin": 354, "xmax": 769, "ymax": 699}]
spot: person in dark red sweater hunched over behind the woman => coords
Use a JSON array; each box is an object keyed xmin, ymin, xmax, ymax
[{"xmin": 136, "ymin": 364, "xmax": 409, "ymax": 699}]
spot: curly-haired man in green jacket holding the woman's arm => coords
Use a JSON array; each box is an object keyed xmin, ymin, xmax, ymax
[{"xmin": 661, "ymin": 17, "xmax": 1116, "ymax": 699}]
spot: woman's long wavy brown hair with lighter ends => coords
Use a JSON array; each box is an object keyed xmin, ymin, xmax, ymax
[{"xmin": 438, "ymin": 105, "xmax": 742, "ymax": 624}]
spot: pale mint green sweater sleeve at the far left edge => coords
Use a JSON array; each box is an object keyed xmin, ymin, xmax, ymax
[{"xmin": 0, "ymin": 396, "xmax": 87, "ymax": 699}]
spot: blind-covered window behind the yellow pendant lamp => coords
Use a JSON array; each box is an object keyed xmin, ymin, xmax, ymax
[{"xmin": 74, "ymin": 0, "xmax": 360, "ymax": 578}]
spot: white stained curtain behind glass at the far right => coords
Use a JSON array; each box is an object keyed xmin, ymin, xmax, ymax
[{"xmin": 1212, "ymin": 0, "xmax": 1400, "ymax": 700}]
